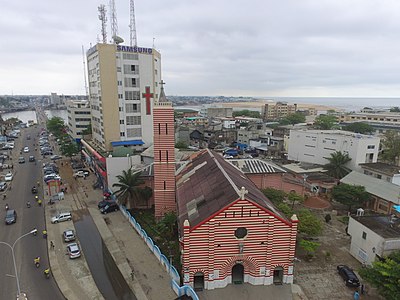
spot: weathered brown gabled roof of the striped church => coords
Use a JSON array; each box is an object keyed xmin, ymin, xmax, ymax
[{"xmin": 176, "ymin": 149, "xmax": 289, "ymax": 228}]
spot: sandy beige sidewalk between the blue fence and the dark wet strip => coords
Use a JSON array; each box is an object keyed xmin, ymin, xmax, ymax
[{"xmin": 49, "ymin": 160, "xmax": 177, "ymax": 300}]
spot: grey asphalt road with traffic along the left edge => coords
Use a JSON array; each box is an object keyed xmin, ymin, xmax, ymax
[{"xmin": 0, "ymin": 123, "xmax": 64, "ymax": 300}]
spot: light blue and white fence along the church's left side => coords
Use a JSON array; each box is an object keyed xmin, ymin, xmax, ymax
[{"xmin": 121, "ymin": 206, "xmax": 199, "ymax": 300}]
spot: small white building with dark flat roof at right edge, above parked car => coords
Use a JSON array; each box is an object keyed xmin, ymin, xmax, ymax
[{"xmin": 348, "ymin": 215, "xmax": 400, "ymax": 265}]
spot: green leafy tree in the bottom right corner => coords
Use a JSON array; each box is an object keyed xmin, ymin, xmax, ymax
[{"xmin": 358, "ymin": 251, "xmax": 400, "ymax": 300}]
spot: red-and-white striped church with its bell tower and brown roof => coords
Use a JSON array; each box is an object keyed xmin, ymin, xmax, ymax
[{"xmin": 153, "ymin": 84, "xmax": 298, "ymax": 289}]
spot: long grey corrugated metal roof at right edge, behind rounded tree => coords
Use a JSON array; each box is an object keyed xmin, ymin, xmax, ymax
[{"xmin": 340, "ymin": 171, "xmax": 400, "ymax": 204}]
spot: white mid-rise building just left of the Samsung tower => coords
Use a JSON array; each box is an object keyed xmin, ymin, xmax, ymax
[{"xmin": 66, "ymin": 100, "xmax": 91, "ymax": 140}]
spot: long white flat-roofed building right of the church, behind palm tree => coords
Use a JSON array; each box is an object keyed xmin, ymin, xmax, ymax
[{"xmin": 288, "ymin": 130, "xmax": 380, "ymax": 171}]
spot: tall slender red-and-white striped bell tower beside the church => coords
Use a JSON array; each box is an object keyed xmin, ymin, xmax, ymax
[{"xmin": 153, "ymin": 87, "xmax": 176, "ymax": 218}]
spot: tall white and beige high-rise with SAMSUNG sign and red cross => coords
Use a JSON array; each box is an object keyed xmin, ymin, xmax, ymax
[{"xmin": 87, "ymin": 43, "xmax": 161, "ymax": 152}]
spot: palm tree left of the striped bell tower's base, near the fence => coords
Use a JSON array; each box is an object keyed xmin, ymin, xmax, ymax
[{"xmin": 112, "ymin": 169, "xmax": 144, "ymax": 207}]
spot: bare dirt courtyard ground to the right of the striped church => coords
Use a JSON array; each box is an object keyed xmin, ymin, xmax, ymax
[{"xmin": 294, "ymin": 200, "xmax": 382, "ymax": 300}]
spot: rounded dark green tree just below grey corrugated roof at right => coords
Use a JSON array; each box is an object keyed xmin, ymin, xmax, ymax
[{"xmin": 332, "ymin": 183, "xmax": 371, "ymax": 211}]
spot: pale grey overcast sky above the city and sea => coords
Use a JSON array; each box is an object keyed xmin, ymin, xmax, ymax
[{"xmin": 0, "ymin": 0, "xmax": 400, "ymax": 97}]
